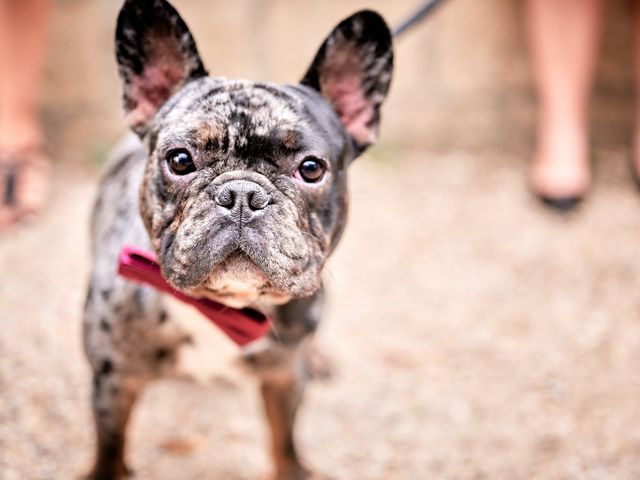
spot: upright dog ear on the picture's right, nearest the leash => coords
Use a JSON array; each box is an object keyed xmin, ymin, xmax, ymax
[{"xmin": 301, "ymin": 10, "xmax": 393, "ymax": 150}]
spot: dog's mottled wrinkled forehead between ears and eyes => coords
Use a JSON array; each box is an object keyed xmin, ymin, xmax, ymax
[{"xmin": 156, "ymin": 77, "xmax": 348, "ymax": 163}]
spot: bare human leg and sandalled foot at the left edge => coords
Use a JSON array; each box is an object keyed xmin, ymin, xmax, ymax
[{"xmin": 0, "ymin": 0, "xmax": 50, "ymax": 230}]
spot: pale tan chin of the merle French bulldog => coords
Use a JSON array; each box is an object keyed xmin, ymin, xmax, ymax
[{"xmin": 185, "ymin": 252, "xmax": 291, "ymax": 308}]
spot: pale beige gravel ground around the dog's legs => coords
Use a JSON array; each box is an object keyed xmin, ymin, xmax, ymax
[{"xmin": 0, "ymin": 150, "xmax": 640, "ymax": 480}]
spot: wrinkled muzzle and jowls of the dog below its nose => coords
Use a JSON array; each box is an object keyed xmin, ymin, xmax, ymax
[{"xmin": 158, "ymin": 204, "xmax": 323, "ymax": 307}]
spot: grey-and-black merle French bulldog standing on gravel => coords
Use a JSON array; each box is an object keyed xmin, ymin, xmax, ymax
[{"xmin": 84, "ymin": 0, "xmax": 393, "ymax": 479}]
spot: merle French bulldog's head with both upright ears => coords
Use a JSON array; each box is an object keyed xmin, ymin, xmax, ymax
[{"xmin": 116, "ymin": 0, "xmax": 393, "ymax": 306}]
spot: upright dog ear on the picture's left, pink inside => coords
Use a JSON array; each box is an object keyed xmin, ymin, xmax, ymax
[{"xmin": 116, "ymin": 0, "xmax": 207, "ymax": 136}]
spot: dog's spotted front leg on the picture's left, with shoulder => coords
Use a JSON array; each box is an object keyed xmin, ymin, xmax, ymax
[{"xmin": 84, "ymin": 278, "xmax": 179, "ymax": 480}]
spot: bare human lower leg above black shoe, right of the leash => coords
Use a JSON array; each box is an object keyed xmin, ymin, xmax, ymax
[{"xmin": 526, "ymin": 0, "xmax": 604, "ymax": 209}]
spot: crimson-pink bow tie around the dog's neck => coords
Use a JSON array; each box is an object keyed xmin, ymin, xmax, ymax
[{"xmin": 118, "ymin": 245, "xmax": 270, "ymax": 346}]
